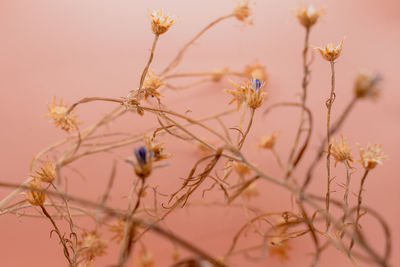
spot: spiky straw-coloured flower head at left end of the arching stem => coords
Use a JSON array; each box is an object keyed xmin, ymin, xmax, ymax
[{"xmin": 45, "ymin": 97, "xmax": 80, "ymax": 132}]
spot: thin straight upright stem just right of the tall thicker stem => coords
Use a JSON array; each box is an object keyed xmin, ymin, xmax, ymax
[{"xmin": 325, "ymin": 61, "xmax": 335, "ymax": 232}]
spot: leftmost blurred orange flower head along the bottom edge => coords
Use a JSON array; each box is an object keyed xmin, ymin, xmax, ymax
[{"xmin": 78, "ymin": 230, "xmax": 107, "ymax": 261}]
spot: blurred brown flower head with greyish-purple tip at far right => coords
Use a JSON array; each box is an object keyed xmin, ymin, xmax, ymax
[{"xmin": 354, "ymin": 72, "xmax": 382, "ymax": 99}]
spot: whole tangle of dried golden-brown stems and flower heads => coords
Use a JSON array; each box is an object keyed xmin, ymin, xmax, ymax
[{"xmin": 0, "ymin": 1, "xmax": 391, "ymax": 267}]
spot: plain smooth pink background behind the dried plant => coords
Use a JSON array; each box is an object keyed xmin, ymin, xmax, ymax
[{"xmin": 0, "ymin": 0, "xmax": 400, "ymax": 266}]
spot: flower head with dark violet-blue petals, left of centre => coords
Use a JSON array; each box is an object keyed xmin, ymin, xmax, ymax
[{"xmin": 127, "ymin": 146, "xmax": 153, "ymax": 179}]
